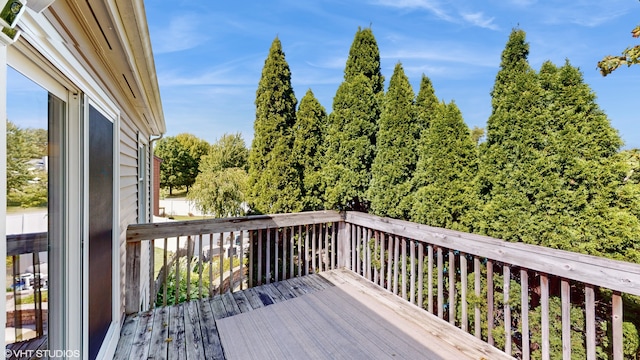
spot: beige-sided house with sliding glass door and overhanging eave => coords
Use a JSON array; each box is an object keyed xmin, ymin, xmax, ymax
[{"xmin": 0, "ymin": 0, "xmax": 165, "ymax": 359}]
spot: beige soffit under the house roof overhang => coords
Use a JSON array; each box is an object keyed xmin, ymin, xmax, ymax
[{"xmin": 45, "ymin": 0, "xmax": 166, "ymax": 135}]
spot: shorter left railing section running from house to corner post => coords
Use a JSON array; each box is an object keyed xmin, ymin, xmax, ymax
[{"xmin": 125, "ymin": 211, "xmax": 342, "ymax": 313}]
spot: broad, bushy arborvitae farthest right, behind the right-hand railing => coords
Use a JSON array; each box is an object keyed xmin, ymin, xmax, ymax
[{"xmin": 530, "ymin": 61, "xmax": 640, "ymax": 262}]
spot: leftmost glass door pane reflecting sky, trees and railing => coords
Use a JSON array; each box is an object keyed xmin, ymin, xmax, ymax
[{"xmin": 5, "ymin": 68, "xmax": 52, "ymax": 348}]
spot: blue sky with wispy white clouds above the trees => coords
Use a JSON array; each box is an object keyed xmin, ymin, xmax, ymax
[{"xmin": 145, "ymin": 0, "xmax": 640, "ymax": 148}]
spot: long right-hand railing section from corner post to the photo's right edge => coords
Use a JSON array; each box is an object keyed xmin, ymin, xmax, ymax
[{"xmin": 345, "ymin": 212, "xmax": 640, "ymax": 360}]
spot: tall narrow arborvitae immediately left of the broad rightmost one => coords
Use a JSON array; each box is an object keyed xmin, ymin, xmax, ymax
[{"xmin": 474, "ymin": 30, "xmax": 544, "ymax": 241}]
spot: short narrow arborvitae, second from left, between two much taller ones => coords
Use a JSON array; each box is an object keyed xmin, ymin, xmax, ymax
[{"xmin": 293, "ymin": 89, "xmax": 327, "ymax": 210}]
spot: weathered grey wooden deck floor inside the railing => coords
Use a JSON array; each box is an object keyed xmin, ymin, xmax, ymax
[{"xmin": 115, "ymin": 270, "xmax": 510, "ymax": 360}]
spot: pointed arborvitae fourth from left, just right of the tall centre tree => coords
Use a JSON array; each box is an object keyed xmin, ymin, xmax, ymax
[{"xmin": 368, "ymin": 63, "xmax": 423, "ymax": 220}]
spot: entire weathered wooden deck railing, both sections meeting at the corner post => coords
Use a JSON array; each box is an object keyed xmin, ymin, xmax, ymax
[{"xmin": 126, "ymin": 211, "xmax": 640, "ymax": 360}]
